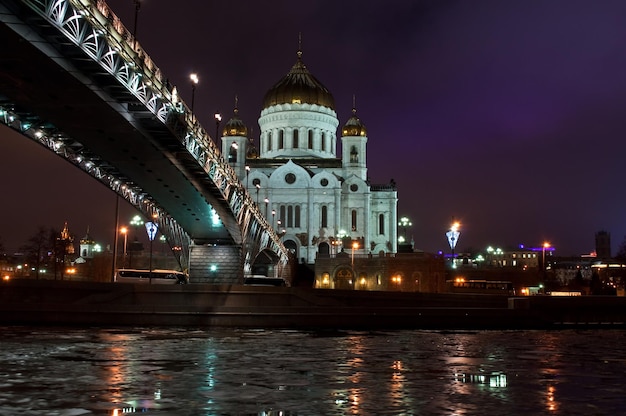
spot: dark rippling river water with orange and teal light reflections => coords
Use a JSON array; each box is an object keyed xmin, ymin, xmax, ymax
[{"xmin": 0, "ymin": 327, "xmax": 626, "ymax": 416}]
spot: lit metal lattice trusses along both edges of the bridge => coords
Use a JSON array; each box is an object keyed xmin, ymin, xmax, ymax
[{"xmin": 0, "ymin": 0, "xmax": 289, "ymax": 276}]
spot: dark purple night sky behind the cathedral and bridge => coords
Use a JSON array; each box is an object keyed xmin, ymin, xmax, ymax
[{"xmin": 0, "ymin": 0, "xmax": 626, "ymax": 255}]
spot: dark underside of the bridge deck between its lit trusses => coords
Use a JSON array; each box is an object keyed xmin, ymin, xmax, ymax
[{"xmin": 0, "ymin": 13, "xmax": 236, "ymax": 245}]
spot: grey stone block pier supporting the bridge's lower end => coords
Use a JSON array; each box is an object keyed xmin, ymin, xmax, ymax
[{"xmin": 189, "ymin": 245, "xmax": 243, "ymax": 284}]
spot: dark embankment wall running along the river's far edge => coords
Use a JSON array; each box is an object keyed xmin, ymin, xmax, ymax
[{"xmin": 0, "ymin": 279, "xmax": 626, "ymax": 329}]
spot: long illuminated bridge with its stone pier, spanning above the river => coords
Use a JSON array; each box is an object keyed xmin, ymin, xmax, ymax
[{"xmin": 0, "ymin": 0, "xmax": 289, "ymax": 283}]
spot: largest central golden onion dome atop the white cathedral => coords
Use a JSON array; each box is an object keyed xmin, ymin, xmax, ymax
[{"xmin": 263, "ymin": 51, "xmax": 335, "ymax": 110}]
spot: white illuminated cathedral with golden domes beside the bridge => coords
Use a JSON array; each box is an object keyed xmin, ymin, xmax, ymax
[{"xmin": 221, "ymin": 51, "xmax": 397, "ymax": 264}]
